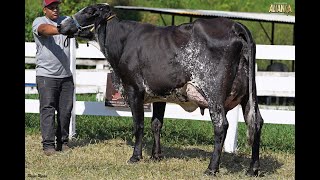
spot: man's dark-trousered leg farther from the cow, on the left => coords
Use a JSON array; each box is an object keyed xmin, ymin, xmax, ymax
[{"xmin": 36, "ymin": 76, "xmax": 58, "ymax": 153}]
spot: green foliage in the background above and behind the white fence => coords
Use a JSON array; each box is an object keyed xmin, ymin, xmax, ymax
[{"xmin": 25, "ymin": 0, "xmax": 295, "ymax": 71}]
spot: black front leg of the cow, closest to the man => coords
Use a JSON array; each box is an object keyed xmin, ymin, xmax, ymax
[{"xmin": 127, "ymin": 88, "xmax": 144, "ymax": 163}]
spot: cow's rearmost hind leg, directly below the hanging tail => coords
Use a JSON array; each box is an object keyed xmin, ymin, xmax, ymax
[{"xmin": 241, "ymin": 95, "xmax": 263, "ymax": 176}]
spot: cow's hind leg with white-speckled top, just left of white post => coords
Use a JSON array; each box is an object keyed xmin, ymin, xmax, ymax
[{"xmin": 205, "ymin": 104, "xmax": 229, "ymax": 175}]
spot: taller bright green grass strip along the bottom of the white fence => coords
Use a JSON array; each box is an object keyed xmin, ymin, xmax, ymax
[{"xmin": 25, "ymin": 94, "xmax": 295, "ymax": 153}]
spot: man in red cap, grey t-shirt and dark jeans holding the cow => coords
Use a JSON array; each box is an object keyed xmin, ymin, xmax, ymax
[{"xmin": 32, "ymin": 0, "xmax": 74, "ymax": 155}]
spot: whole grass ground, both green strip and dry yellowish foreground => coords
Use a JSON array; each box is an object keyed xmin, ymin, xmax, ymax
[{"xmin": 25, "ymin": 95, "xmax": 295, "ymax": 180}]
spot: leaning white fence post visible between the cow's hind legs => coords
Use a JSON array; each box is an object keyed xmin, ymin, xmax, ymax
[{"xmin": 224, "ymin": 105, "xmax": 239, "ymax": 153}]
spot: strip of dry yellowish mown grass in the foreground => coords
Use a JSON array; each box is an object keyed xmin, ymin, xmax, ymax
[{"xmin": 25, "ymin": 135, "xmax": 295, "ymax": 180}]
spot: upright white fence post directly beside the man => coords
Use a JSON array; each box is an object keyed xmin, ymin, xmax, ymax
[{"xmin": 69, "ymin": 38, "xmax": 76, "ymax": 139}]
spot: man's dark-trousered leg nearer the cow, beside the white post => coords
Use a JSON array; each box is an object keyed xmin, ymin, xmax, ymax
[{"xmin": 56, "ymin": 77, "xmax": 74, "ymax": 151}]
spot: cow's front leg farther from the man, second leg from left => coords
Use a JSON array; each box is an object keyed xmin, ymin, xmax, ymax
[{"xmin": 151, "ymin": 102, "xmax": 166, "ymax": 160}]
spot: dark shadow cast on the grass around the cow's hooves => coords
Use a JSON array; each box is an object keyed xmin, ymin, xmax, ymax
[{"xmin": 70, "ymin": 135, "xmax": 283, "ymax": 177}]
